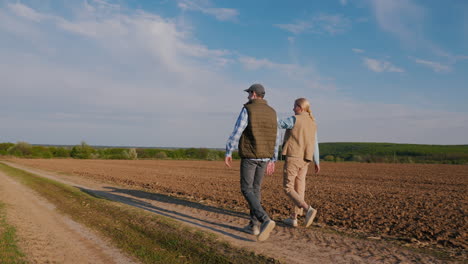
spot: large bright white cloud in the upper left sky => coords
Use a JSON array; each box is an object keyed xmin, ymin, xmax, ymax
[{"xmin": 57, "ymin": 5, "xmax": 230, "ymax": 73}]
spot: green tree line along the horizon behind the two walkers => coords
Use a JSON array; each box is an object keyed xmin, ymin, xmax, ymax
[{"xmin": 0, "ymin": 142, "xmax": 468, "ymax": 164}]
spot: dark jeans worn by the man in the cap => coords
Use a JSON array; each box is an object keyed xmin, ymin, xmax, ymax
[{"xmin": 240, "ymin": 159, "xmax": 270, "ymax": 225}]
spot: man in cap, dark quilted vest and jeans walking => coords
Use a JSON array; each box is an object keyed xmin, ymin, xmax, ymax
[{"xmin": 225, "ymin": 84, "xmax": 279, "ymax": 241}]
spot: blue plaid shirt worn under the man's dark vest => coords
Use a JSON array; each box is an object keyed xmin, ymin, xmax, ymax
[{"xmin": 226, "ymin": 107, "xmax": 280, "ymax": 162}]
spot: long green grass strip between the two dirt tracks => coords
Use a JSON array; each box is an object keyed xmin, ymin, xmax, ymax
[{"xmin": 0, "ymin": 163, "xmax": 279, "ymax": 263}]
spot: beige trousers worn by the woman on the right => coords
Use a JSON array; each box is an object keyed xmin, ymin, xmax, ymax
[{"xmin": 283, "ymin": 157, "xmax": 310, "ymax": 216}]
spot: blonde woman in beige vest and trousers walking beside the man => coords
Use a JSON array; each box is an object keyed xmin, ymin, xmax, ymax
[{"xmin": 278, "ymin": 98, "xmax": 320, "ymax": 227}]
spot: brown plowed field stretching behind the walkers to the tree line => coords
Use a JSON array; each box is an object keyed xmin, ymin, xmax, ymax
[{"xmin": 8, "ymin": 159, "xmax": 468, "ymax": 259}]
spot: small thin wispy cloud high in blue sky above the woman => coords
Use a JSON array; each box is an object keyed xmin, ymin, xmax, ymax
[{"xmin": 274, "ymin": 14, "xmax": 351, "ymax": 35}]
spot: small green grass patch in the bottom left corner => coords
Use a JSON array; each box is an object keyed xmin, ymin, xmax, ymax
[{"xmin": 0, "ymin": 202, "xmax": 26, "ymax": 264}]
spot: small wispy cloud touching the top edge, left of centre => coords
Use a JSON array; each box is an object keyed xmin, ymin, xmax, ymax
[{"xmin": 178, "ymin": 0, "xmax": 239, "ymax": 21}]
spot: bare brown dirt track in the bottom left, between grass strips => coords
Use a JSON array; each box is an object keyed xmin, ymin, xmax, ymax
[{"xmin": 0, "ymin": 168, "xmax": 133, "ymax": 264}]
